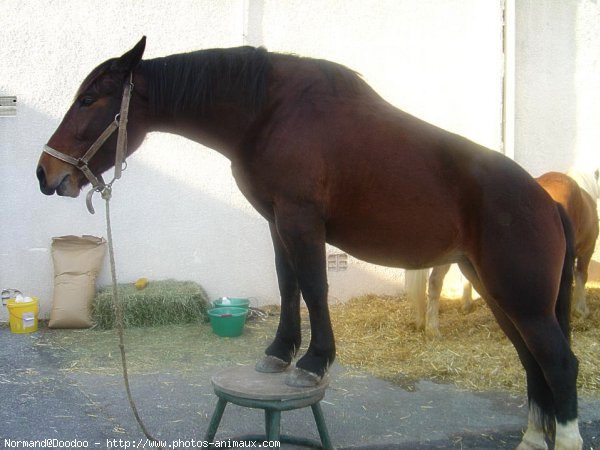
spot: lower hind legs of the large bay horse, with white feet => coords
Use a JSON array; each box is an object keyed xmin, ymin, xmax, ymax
[{"xmin": 460, "ymin": 261, "xmax": 581, "ymax": 450}]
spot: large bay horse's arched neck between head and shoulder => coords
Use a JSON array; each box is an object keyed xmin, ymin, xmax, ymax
[{"xmin": 140, "ymin": 48, "xmax": 266, "ymax": 159}]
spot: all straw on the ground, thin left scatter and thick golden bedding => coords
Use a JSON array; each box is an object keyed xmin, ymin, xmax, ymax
[{"xmin": 54, "ymin": 282, "xmax": 600, "ymax": 397}]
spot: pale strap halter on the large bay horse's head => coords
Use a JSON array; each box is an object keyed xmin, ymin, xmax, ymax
[{"xmin": 44, "ymin": 72, "xmax": 133, "ymax": 214}]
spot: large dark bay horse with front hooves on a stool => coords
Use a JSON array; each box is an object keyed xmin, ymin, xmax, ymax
[{"xmin": 37, "ymin": 39, "xmax": 582, "ymax": 449}]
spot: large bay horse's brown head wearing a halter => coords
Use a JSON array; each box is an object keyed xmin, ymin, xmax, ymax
[{"xmin": 37, "ymin": 37, "xmax": 146, "ymax": 197}]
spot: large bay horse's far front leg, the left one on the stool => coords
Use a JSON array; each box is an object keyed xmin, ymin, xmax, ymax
[{"xmin": 256, "ymin": 223, "xmax": 302, "ymax": 373}]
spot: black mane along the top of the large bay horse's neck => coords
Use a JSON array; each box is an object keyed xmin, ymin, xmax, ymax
[{"xmin": 139, "ymin": 47, "xmax": 370, "ymax": 115}]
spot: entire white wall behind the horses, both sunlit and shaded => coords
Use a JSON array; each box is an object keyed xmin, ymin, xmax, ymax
[{"xmin": 9, "ymin": 0, "xmax": 600, "ymax": 317}]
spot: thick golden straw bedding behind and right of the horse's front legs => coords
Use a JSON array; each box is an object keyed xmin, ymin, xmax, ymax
[{"xmin": 331, "ymin": 286, "xmax": 600, "ymax": 395}]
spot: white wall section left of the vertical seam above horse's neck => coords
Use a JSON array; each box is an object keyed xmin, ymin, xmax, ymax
[{"xmin": 0, "ymin": 0, "xmax": 260, "ymax": 317}]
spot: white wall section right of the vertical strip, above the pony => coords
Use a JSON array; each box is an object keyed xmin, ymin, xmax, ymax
[{"xmin": 515, "ymin": 0, "xmax": 600, "ymax": 176}]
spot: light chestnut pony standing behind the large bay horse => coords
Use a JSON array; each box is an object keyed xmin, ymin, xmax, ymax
[{"xmin": 406, "ymin": 171, "xmax": 599, "ymax": 337}]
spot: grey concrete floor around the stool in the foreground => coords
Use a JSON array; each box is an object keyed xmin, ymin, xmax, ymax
[{"xmin": 0, "ymin": 327, "xmax": 600, "ymax": 450}]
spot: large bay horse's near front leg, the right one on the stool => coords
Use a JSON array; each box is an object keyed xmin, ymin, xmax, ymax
[{"xmin": 275, "ymin": 205, "xmax": 335, "ymax": 386}]
